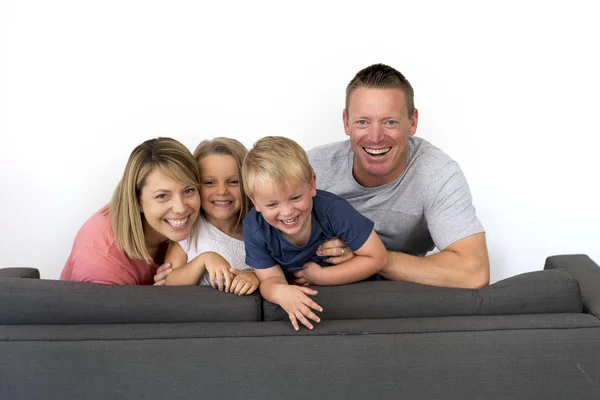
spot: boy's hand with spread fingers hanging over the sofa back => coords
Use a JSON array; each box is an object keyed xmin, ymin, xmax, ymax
[{"xmin": 278, "ymin": 284, "xmax": 323, "ymax": 330}]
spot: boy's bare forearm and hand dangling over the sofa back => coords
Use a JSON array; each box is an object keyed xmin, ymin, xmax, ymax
[{"xmin": 254, "ymin": 265, "xmax": 323, "ymax": 330}]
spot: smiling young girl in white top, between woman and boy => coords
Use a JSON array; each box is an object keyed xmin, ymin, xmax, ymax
[{"xmin": 165, "ymin": 138, "xmax": 259, "ymax": 295}]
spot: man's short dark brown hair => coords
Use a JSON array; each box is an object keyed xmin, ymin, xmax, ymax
[{"xmin": 346, "ymin": 64, "xmax": 415, "ymax": 117}]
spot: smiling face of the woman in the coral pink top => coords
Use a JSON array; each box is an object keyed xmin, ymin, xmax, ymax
[{"xmin": 139, "ymin": 170, "xmax": 200, "ymax": 246}]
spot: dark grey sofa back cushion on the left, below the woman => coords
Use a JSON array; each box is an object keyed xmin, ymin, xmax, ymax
[{"xmin": 0, "ymin": 278, "xmax": 261, "ymax": 324}]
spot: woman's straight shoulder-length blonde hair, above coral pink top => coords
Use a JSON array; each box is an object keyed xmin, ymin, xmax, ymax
[{"xmin": 108, "ymin": 138, "xmax": 200, "ymax": 262}]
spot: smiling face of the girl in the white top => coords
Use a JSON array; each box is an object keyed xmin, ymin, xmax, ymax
[{"xmin": 199, "ymin": 154, "xmax": 242, "ymax": 225}]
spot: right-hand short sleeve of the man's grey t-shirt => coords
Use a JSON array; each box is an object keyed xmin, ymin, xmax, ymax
[{"xmin": 425, "ymin": 162, "xmax": 484, "ymax": 250}]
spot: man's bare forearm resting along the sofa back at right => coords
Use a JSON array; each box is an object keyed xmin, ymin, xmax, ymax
[{"xmin": 379, "ymin": 250, "xmax": 490, "ymax": 288}]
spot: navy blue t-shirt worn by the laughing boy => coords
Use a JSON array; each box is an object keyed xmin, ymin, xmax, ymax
[{"xmin": 243, "ymin": 190, "xmax": 374, "ymax": 275}]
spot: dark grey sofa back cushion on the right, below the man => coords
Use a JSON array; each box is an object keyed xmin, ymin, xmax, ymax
[{"xmin": 263, "ymin": 270, "xmax": 582, "ymax": 321}]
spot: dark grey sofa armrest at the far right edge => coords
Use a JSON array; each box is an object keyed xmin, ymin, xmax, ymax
[{"xmin": 544, "ymin": 254, "xmax": 600, "ymax": 318}]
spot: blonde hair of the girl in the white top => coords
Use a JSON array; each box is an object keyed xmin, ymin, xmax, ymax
[{"xmin": 194, "ymin": 137, "xmax": 250, "ymax": 228}]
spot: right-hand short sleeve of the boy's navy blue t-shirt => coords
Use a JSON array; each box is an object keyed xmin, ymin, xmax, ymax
[{"xmin": 327, "ymin": 198, "xmax": 374, "ymax": 251}]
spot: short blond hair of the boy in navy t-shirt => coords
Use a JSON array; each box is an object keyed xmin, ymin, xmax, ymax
[{"xmin": 242, "ymin": 136, "xmax": 313, "ymax": 196}]
